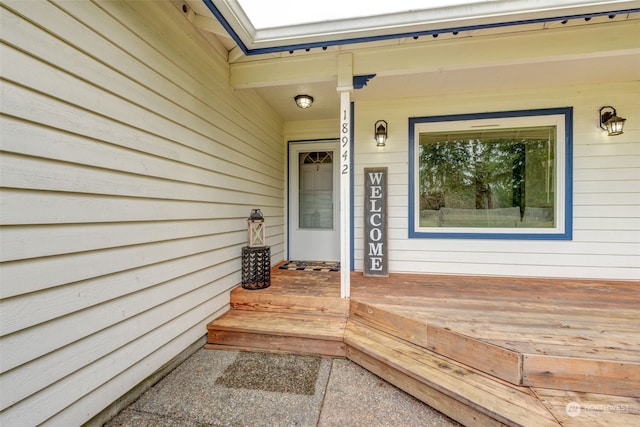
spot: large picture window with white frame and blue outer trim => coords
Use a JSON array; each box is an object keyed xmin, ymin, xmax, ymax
[{"xmin": 409, "ymin": 108, "xmax": 571, "ymax": 239}]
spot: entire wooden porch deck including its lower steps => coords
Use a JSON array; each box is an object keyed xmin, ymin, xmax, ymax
[{"xmin": 207, "ymin": 267, "xmax": 640, "ymax": 426}]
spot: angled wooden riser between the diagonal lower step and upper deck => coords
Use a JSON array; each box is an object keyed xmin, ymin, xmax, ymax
[{"xmin": 350, "ymin": 301, "xmax": 522, "ymax": 385}]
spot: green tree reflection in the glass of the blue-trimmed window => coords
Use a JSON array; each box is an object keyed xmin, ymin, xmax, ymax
[{"xmin": 418, "ymin": 126, "xmax": 555, "ymax": 227}]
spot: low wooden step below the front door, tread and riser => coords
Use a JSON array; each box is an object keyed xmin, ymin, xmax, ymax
[{"xmin": 205, "ymin": 310, "xmax": 346, "ymax": 357}]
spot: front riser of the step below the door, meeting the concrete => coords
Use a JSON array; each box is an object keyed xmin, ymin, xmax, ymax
[{"xmin": 207, "ymin": 329, "xmax": 346, "ymax": 357}]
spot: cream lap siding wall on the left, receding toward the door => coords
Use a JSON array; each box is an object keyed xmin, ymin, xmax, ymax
[{"xmin": 0, "ymin": 1, "xmax": 285, "ymax": 425}]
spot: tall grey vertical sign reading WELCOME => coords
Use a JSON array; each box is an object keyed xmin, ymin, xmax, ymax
[{"xmin": 364, "ymin": 168, "xmax": 389, "ymax": 277}]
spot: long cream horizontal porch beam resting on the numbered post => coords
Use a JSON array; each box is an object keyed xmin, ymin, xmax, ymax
[{"xmin": 230, "ymin": 19, "xmax": 640, "ymax": 89}]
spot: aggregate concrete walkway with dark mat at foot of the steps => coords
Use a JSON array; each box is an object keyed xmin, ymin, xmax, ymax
[{"xmin": 106, "ymin": 349, "xmax": 459, "ymax": 427}]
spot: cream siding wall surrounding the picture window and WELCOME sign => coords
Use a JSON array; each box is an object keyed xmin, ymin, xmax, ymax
[{"xmin": 354, "ymin": 82, "xmax": 640, "ymax": 280}]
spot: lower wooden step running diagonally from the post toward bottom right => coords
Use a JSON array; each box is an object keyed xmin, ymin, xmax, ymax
[{"xmin": 345, "ymin": 319, "xmax": 560, "ymax": 427}]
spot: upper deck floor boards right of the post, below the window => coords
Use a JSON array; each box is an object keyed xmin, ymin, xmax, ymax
[{"xmin": 351, "ymin": 273, "xmax": 640, "ymax": 363}]
